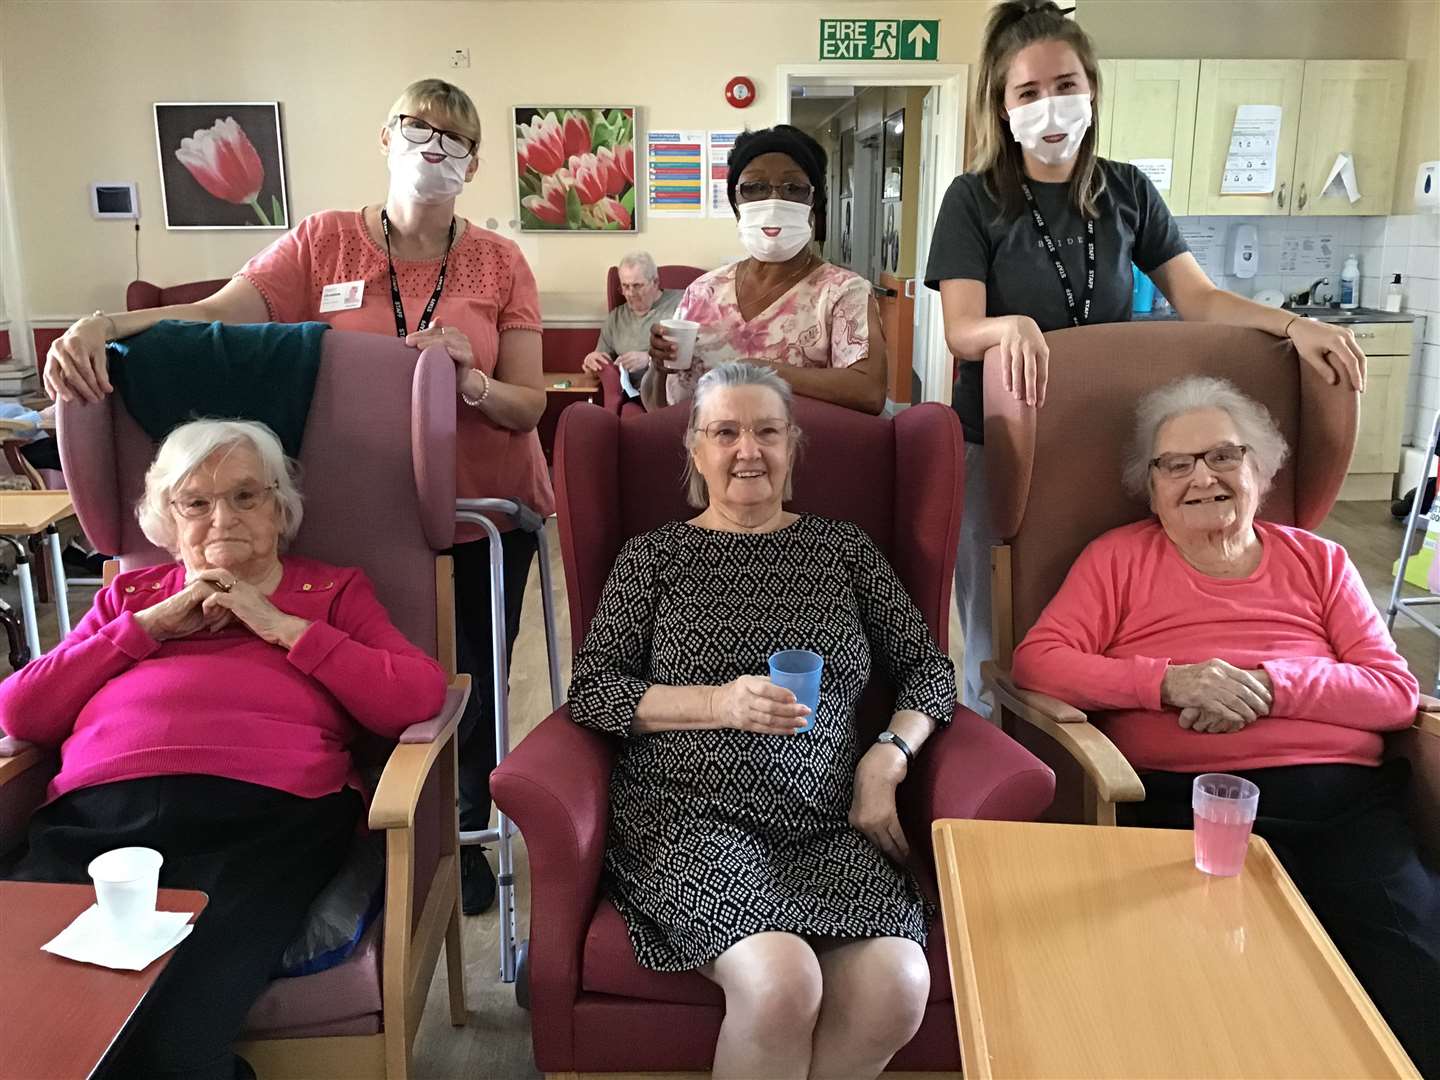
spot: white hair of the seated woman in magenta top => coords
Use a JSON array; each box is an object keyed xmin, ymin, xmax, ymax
[{"xmin": 135, "ymin": 420, "xmax": 302, "ymax": 554}]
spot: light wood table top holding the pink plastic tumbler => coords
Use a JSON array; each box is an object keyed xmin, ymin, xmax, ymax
[{"xmin": 933, "ymin": 819, "xmax": 1418, "ymax": 1080}]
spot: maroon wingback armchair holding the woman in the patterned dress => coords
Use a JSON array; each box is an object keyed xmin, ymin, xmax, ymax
[{"xmin": 491, "ymin": 399, "xmax": 1054, "ymax": 1073}]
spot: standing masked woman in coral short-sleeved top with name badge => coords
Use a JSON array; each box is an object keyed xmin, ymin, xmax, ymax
[{"xmin": 45, "ymin": 79, "xmax": 554, "ymax": 914}]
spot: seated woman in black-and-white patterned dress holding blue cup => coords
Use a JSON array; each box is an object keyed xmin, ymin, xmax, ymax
[{"xmin": 570, "ymin": 364, "xmax": 955, "ymax": 1077}]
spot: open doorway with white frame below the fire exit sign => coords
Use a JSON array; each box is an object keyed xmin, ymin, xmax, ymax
[{"xmin": 778, "ymin": 63, "xmax": 966, "ymax": 408}]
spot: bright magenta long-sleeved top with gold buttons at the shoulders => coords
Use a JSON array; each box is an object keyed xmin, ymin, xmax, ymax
[{"xmin": 0, "ymin": 557, "xmax": 445, "ymax": 799}]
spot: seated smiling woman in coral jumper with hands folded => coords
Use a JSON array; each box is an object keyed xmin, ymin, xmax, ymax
[{"xmin": 1014, "ymin": 377, "xmax": 1440, "ymax": 1076}]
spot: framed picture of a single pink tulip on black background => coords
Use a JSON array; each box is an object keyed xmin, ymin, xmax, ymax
[{"xmin": 156, "ymin": 101, "xmax": 289, "ymax": 229}]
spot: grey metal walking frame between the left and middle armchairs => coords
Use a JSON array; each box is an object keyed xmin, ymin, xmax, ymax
[{"xmin": 455, "ymin": 498, "xmax": 564, "ymax": 982}]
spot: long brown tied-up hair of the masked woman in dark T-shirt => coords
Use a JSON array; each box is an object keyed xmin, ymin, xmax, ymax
[{"xmin": 975, "ymin": 0, "xmax": 1104, "ymax": 219}]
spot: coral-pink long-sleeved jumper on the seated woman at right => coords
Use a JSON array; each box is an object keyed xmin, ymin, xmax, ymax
[{"xmin": 1014, "ymin": 520, "xmax": 1420, "ymax": 772}]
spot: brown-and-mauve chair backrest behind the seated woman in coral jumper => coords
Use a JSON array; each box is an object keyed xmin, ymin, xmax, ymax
[{"xmin": 985, "ymin": 323, "xmax": 1359, "ymax": 650}]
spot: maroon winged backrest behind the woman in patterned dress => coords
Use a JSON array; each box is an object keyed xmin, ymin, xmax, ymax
[{"xmin": 554, "ymin": 397, "xmax": 963, "ymax": 726}]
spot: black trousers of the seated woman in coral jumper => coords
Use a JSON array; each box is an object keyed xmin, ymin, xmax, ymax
[{"xmin": 1117, "ymin": 760, "xmax": 1440, "ymax": 1077}]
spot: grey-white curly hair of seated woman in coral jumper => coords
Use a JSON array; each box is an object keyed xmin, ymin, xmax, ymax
[{"xmin": 1122, "ymin": 374, "xmax": 1290, "ymax": 500}]
